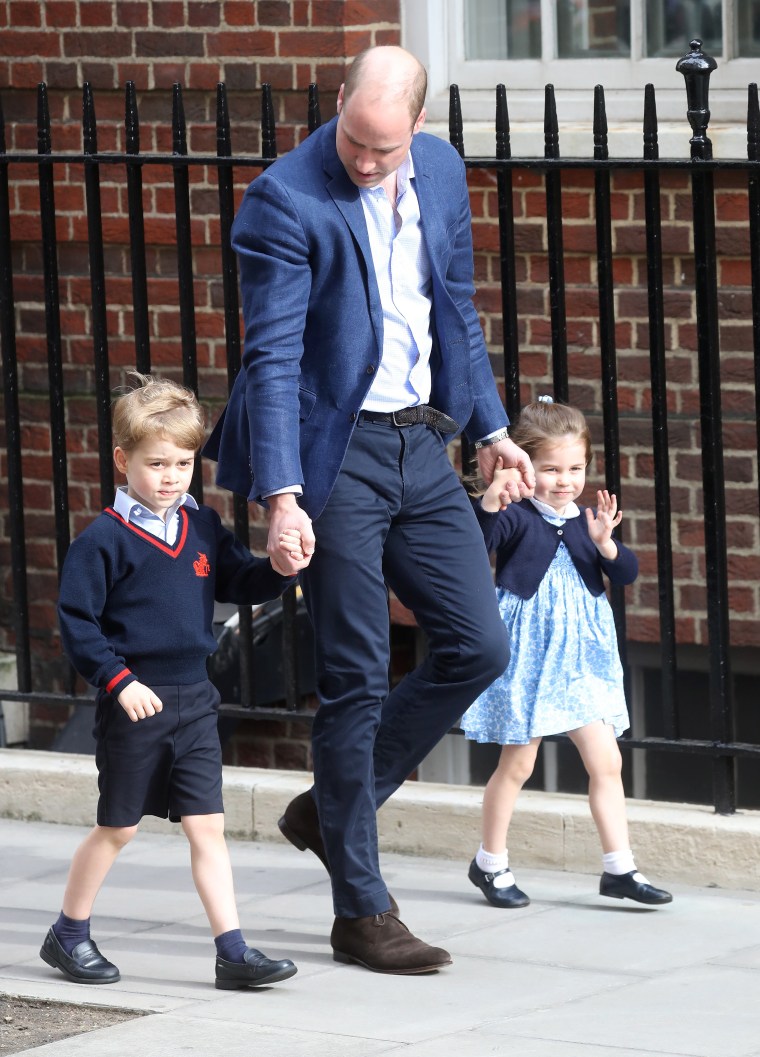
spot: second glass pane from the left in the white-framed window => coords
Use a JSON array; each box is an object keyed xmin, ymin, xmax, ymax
[{"xmin": 557, "ymin": 0, "xmax": 631, "ymax": 59}]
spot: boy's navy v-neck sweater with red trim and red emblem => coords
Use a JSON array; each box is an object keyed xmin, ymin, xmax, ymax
[{"xmin": 58, "ymin": 506, "xmax": 295, "ymax": 696}]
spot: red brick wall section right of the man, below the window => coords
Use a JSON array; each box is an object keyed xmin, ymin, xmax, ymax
[{"xmin": 469, "ymin": 170, "xmax": 760, "ymax": 647}]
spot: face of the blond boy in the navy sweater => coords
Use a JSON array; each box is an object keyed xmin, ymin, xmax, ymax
[{"xmin": 113, "ymin": 435, "xmax": 196, "ymax": 519}]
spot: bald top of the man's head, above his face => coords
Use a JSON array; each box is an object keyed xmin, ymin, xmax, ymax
[{"xmin": 342, "ymin": 45, "xmax": 427, "ymax": 125}]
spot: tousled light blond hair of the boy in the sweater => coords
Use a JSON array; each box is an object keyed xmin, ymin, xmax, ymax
[{"xmin": 113, "ymin": 371, "xmax": 205, "ymax": 451}]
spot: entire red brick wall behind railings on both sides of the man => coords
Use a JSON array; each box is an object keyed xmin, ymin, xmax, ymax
[{"xmin": 0, "ymin": 0, "xmax": 760, "ymax": 765}]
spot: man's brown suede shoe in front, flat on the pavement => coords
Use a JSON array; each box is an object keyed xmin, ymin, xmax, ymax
[{"xmin": 330, "ymin": 913, "xmax": 451, "ymax": 976}]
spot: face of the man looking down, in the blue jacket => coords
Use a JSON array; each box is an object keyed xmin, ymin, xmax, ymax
[{"xmin": 335, "ymin": 87, "xmax": 425, "ymax": 187}]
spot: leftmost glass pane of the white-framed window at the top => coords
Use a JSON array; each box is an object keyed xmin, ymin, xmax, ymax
[{"xmin": 465, "ymin": 0, "xmax": 541, "ymax": 59}]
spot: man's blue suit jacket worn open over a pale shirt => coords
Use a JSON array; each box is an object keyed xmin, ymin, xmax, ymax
[{"xmin": 203, "ymin": 118, "xmax": 507, "ymax": 518}]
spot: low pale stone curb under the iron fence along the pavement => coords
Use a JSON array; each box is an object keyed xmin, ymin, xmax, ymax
[{"xmin": 0, "ymin": 748, "xmax": 760, "ymax": 891}]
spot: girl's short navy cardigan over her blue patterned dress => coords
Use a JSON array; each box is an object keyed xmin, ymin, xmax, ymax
[{"xmin": 474, "ymin": 499, "xmax": 638, "ymax": 598}]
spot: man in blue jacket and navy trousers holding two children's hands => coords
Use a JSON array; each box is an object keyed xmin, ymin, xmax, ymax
[{"xmin": 206, "ymin": 47, "xmax": 534, "ymax": 973}]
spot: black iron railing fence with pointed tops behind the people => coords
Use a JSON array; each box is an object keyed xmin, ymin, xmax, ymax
[{"xmin": 0, "ymin": 41, "xmax": 760, "ymax": 813}]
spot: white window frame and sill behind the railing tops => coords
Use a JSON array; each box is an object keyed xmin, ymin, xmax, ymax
[{"xmin": 402, "ymin": 0, "xmax": 760, "ymax": 156}]
